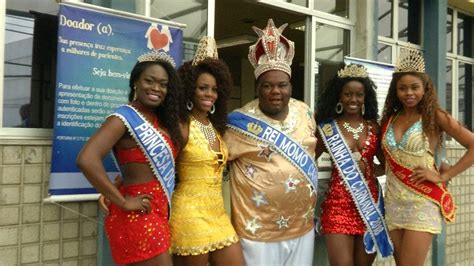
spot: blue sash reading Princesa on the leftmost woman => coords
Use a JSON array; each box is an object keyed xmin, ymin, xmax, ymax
[{"xmin": 110, "ymin": 105, "xmax": 175, "ymax": 207}]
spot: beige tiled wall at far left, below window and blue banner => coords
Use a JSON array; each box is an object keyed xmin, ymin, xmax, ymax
[{"xmin": 0, "ymin": 141, "xmax": 98, "ymax": 266}]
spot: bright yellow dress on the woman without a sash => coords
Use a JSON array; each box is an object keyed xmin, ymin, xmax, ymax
[{"xmin": 170, "ymin": 119, "xmax": 238, "ymax": 256}]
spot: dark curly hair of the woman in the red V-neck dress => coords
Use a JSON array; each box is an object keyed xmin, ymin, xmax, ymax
[{"xmin": 316, "ymin": 66, "xmax": 379, "ymax": 123}]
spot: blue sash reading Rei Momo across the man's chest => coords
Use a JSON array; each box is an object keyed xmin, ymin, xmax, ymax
[{"xmin": 227, "ymin": 111, "xmax": 318, "ymax": 189}]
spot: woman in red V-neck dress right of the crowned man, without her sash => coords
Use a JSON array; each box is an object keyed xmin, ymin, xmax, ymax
[{"xmin": 316, "ymin": 65, "xmax": 380, "ymax": 265}]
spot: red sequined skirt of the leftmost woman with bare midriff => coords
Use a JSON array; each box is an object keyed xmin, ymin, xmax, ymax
[{"xmin": 105, "ymin": 180, "xmax": 171, "ymax": 264}]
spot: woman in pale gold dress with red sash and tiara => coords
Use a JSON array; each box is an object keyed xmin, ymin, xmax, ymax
[{"xmin": 382, "ymin": 48, "xmax": 474, "ymax": 265}]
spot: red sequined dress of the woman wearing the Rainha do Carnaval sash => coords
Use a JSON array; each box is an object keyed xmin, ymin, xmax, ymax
[{"xmin": 321, "ymin": 126, "xmax": 378, "ymax": 235}]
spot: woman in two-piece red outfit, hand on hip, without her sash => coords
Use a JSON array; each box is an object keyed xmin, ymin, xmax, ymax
[{"xmin": 77, "ymin": 53, "xmax": 182, "ymax": 265}]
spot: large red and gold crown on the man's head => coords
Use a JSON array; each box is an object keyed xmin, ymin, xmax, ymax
[{"xmin": 249, "ymin": 19, "xmax": 295, "ymax": 78}]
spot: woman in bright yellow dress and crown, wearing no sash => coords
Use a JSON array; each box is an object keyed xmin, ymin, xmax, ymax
[{"xmin": 170, "ymin": 38, "xmax": 243, "ymax": 266}]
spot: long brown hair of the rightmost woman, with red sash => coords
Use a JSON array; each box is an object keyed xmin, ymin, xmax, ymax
[{"xmin": 382, "ymin": 72, "xmax": 446, "ymax": 139}]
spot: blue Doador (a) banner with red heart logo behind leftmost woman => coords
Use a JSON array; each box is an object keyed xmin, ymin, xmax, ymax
[{"xmin": 49, "ymin": 4, "xmax": 183, "ymax": 195}]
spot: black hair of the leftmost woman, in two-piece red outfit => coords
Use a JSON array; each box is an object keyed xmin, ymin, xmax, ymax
[{"xmin": 128, "ymin": 60, "xmax": 184, "ymax": 149}]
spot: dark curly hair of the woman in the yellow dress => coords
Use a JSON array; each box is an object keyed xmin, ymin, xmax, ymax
[{"xmin": 178, "ymin": 58, "xmax": 233, "ymax": 135}]
